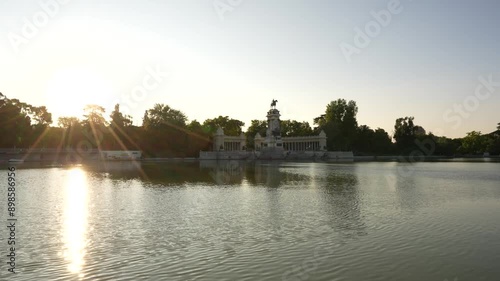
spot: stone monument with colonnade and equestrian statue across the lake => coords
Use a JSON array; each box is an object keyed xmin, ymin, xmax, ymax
[{"xmin": 200, "ymin": 99, "xmax": 354, "ymax": 161}]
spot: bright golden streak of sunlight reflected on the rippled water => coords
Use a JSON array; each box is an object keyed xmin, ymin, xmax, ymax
[{"xmin": 63, "ymin": 168, "xmax": 88, "ymax": 277}]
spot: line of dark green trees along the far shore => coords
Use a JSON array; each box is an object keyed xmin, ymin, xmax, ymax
[{"xmin": 0, "ymin": 93, "xmax": 500, "ymax": 157}]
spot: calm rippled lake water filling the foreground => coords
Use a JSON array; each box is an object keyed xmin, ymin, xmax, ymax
[{"xmin": 0, "ymin": 162, "xmax": 500, "ymax": 281}]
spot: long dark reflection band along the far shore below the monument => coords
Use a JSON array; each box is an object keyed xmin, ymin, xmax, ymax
[{"xmin": 83, "ymin": 160, "xmax": 318, "ymax": 188}]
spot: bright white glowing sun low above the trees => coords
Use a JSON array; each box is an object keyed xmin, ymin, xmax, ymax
[{"xmin": 45, "ymin": 67, "xmax": 113, "ymax": 121}]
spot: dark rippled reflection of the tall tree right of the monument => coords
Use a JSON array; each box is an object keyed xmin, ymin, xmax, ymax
[{"xmin": 322, "ymin": 171, "xmax": 367, "ymax": 238}]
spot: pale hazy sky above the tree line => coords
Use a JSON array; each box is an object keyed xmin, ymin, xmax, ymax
[{"xmin": 0, "ymin": 0, "xmax": 500, "ymax": 137}]
